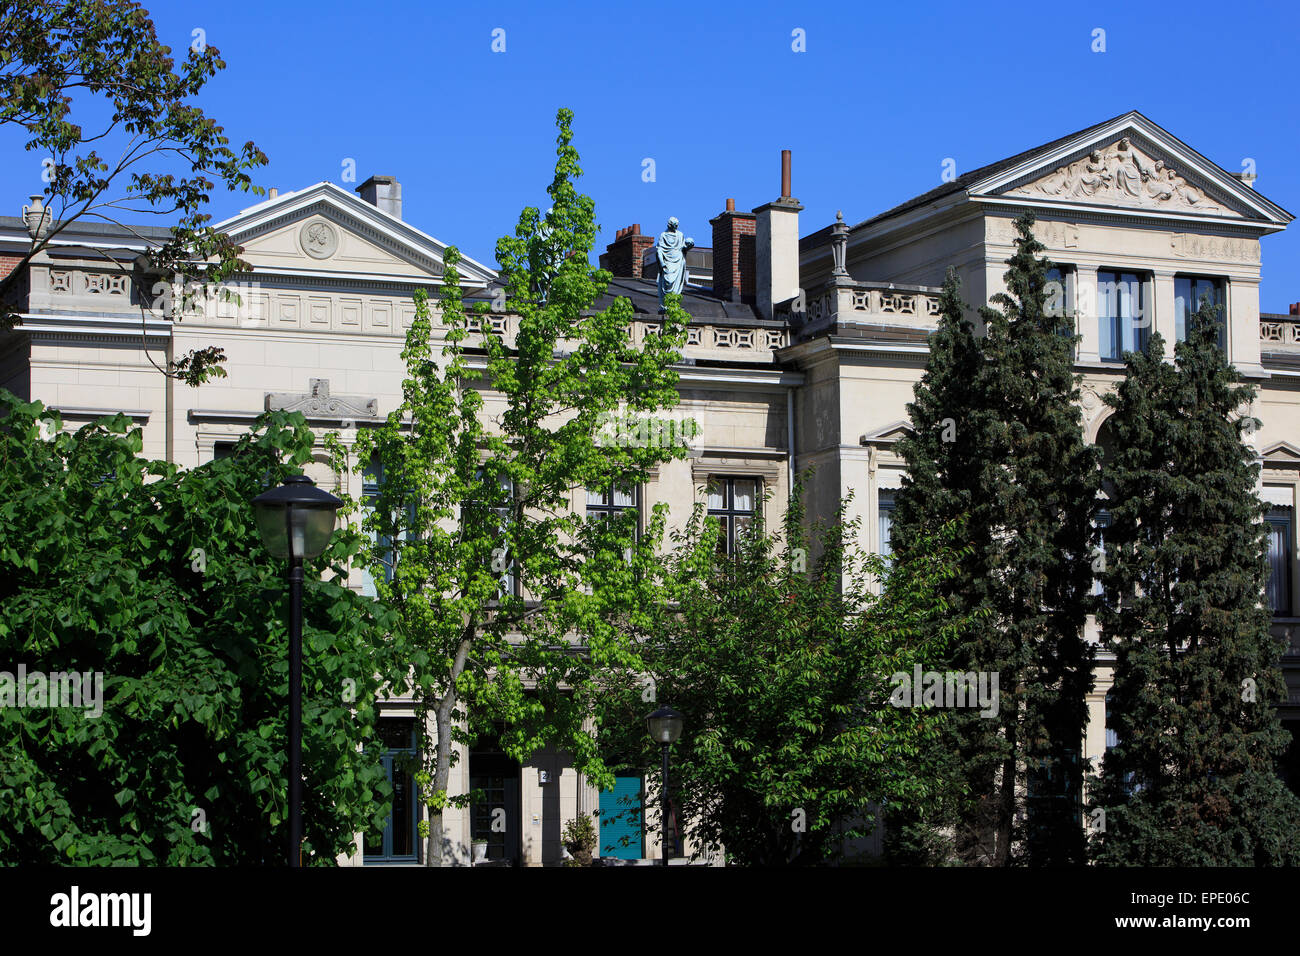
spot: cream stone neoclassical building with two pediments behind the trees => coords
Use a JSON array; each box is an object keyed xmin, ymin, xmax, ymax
[{"xmin": 0, "ymin": 112, "xmax": 1300, "ymax": 865}]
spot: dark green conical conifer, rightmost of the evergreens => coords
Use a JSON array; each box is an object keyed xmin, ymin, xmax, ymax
[{"xmin": 1093, "ymin": 302, "xmax": 1300, "ymax": 866}]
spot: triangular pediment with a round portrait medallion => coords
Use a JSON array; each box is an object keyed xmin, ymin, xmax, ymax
[{"xmin": 217, "ymin": 182, "xmax": 495, "ymax": 289}]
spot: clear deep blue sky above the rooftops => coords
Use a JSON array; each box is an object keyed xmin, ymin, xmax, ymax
[{"xmin": 10, "ymin": 0, "xmax": 1300, "ymax": 312}]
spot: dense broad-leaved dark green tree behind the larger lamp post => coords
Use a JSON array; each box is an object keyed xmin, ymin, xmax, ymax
[{"xmin": 0, "ymin": 392, "xmax": 402, "ymax": 866}]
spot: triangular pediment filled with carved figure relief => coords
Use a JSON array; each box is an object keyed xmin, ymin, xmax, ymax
[{"xmin": 969, "ymin": 112, "xmax": 1294, "ymax": 229}]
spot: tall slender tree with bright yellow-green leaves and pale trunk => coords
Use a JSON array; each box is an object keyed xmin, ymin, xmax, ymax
[{"xmin": 339, "ymin": 109, "xmax": 688, "ymax": 865}]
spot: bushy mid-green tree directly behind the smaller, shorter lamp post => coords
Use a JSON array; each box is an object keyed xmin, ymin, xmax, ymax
[{"xmin": 593, "ymin": 493, "xmax": 977, "ymax": 866}]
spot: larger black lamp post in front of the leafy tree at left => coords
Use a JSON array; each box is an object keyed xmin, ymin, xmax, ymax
[{"xmin": 252, "ymin": 475, "xmax": 343, "ymax": 868}]
